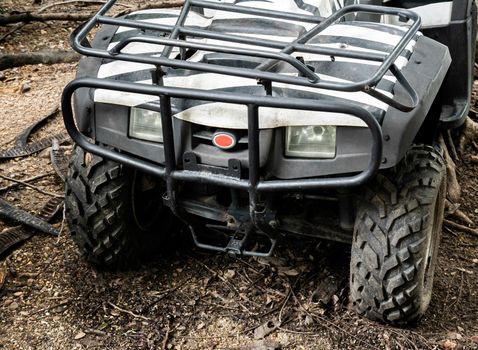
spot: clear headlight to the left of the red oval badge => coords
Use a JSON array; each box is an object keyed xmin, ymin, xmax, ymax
[{"xmin": 129, "ymin": 107, "xmax": 163, "ymax": 142}]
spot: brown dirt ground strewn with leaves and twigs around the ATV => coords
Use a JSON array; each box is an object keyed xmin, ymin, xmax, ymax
[{"xmin": 0, "ymin": 0, "xmax": 478, "ymax": 350}]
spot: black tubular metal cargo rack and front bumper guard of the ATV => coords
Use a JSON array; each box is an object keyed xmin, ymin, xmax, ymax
[{"xmin": 62, "ymin": 0, "xmax": 420, "ymax": 213}]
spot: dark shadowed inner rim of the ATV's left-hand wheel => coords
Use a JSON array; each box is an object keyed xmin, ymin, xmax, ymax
[{"xmin": 131, "ymin": 171, "xmax": 163, "ymax": 231}]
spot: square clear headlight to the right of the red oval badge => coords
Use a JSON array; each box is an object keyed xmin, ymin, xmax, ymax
[{"xmin": 285, "ymin": 126, "xmax": 337, "ymax": 158}]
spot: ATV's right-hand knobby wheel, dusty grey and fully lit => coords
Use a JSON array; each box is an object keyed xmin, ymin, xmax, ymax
[{"xmin": 350, "ymin": 145, "xmax": 446, "ymax": 325}]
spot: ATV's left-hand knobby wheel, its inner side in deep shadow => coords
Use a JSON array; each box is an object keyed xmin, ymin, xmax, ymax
[{"xmin": 65, "ymin": 146, "xmax": 172, "ymax": 269}]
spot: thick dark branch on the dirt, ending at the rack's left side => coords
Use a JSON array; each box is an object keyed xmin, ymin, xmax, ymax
[{"xmin": 0, "ymin": 51, "xmax": 80, "ymax": 71}]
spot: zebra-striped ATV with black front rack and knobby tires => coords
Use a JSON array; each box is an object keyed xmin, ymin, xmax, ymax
[{"xmin": 62, "ymin": 0, "xmax": 476, "ymax": 325}]
